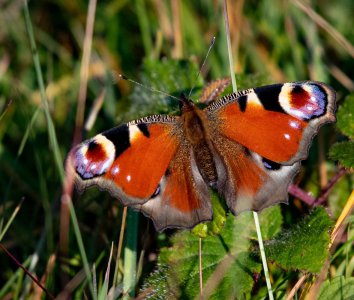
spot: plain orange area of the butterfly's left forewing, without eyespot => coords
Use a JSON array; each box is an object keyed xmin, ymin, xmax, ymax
[{"xmin": 105, "ymin": 124, "xmax": 178, "ymax": 199}]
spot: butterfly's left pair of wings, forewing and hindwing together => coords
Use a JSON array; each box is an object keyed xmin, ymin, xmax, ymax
[{"xmin": 68, "ymin": 115, "xmax": 212, "ymax": 230}]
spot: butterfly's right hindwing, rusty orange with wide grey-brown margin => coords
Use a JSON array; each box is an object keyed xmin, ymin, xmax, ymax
[{"xmin": 210, "ymin": 136, "xmax": 300, "ymax": 214}]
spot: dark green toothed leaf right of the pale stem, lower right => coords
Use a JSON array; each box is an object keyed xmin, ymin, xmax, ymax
[{"xmin": 265, "ymin": 208, "xmax": 333, "ymax": 273}]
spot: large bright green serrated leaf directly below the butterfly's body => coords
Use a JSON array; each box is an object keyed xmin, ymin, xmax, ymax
[{"xmin": 143, "ymin": 206, "xmax": 282, "ymax": 299}]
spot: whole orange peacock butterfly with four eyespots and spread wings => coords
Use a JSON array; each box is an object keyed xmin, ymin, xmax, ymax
[{"xmin": 67, "ymin": 81, "xmax": 336, "ymax": 231}]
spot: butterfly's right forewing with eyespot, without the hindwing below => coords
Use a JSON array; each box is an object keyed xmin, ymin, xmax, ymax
[{"xmin": 207, "ymin": 82, "xmax": 335, "ymax": 164}]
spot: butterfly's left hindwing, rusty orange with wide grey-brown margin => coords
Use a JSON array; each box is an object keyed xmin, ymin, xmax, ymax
[{"xmin": 134, "ymin": 141, "xmax": 213, "ymax": 231}]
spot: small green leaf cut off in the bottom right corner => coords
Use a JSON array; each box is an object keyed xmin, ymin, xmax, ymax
[{"xmin": 318, "ymin": 276, "xmax": 354, "ymax": 300}]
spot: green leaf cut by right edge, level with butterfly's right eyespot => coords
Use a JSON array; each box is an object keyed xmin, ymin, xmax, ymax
[{"xmin": 337, "ymin": 94, "xmax": 354, "ymax": 138}]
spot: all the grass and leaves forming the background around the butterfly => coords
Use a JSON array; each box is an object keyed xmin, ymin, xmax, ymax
[{"xmin": 0, "ymin": 0, "xmax": 354, "ymax": 299}]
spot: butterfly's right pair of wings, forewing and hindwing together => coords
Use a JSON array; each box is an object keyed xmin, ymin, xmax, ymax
[{"xmin": 207, "ymin": 82, "xmax": 335, "ymax": 213}]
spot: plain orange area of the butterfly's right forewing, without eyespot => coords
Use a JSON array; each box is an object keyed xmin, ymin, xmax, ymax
[{"xmin": 218, "ymin": 103, "xmax": 307, "ymax": 163}]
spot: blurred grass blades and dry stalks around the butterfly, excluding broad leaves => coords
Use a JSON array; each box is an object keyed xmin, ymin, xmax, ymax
[{"xmin": 0, "ymin": 0, "xmax": 354, "ymax": 299}]
